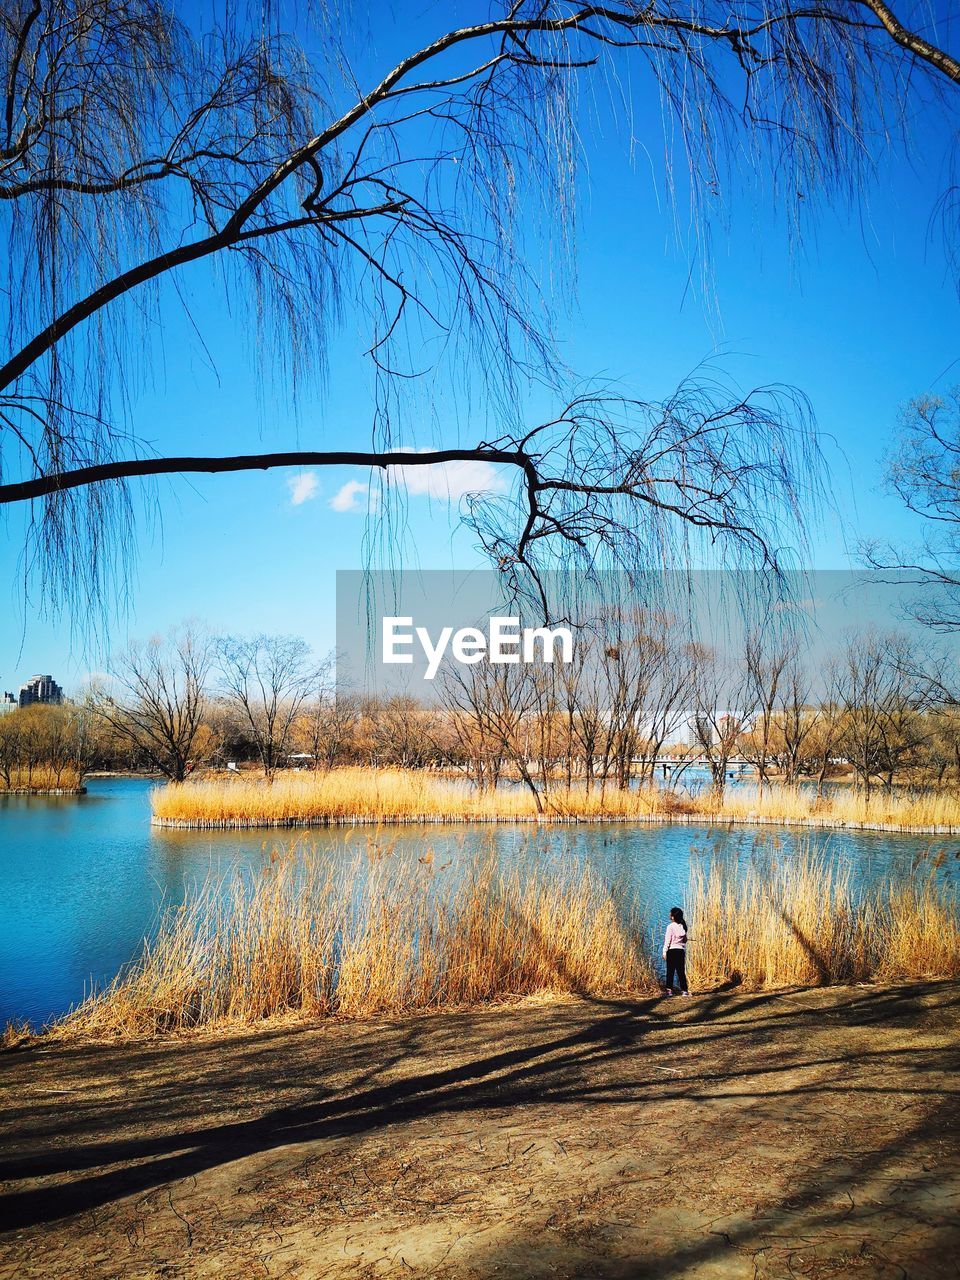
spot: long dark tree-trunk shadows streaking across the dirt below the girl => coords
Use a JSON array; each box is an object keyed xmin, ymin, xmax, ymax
[{"xmin": 0, "ymin": 983, "xmax": 960, "ymax": 1239}]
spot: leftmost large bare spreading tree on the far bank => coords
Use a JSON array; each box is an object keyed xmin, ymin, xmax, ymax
[{"xmin": 93, "ymin": 627, "xmax": 212, "ymax": 782}]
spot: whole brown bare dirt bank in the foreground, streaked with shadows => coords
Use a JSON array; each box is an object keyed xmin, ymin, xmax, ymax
[{"xmin": 0, "ymin": 983, "xmax": 960, "ymax": 1280}]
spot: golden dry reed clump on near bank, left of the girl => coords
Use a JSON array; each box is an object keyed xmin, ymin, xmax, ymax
[{"xmin": 56, "ymin": 855, "xmax": 654, "ymax": 1037}]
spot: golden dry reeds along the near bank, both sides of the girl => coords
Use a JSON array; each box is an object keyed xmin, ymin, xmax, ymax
[{"xmin": 54, "ymin": 846, "xmax": 960, "ymax": 1037}]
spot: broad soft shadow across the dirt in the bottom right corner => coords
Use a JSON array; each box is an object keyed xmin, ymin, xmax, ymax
[{"xmin": 445, "ymin": 1044, "xmax": 960, "ymax": 1280}]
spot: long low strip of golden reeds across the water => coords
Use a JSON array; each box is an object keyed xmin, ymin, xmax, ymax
[{"xmin": 152, "ymin": 768, "xmax": 960, "ymax": 831}]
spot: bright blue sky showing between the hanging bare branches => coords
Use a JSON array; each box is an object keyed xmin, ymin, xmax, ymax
[{"xmin": 0, "ymin": 4, "xmax": 960, "ymax": 687}]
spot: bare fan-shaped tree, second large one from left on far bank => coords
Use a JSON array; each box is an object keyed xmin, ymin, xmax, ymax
[{"xmin": 218, "ymin": 635, "xmax": 316, "ymax": 778}]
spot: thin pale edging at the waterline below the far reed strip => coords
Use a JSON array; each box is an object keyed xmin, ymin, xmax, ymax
[{"xmin": 150, "ymin": 813, "xmax": 960, "ymax": 836}]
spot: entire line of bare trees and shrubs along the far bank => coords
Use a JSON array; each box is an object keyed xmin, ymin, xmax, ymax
[{"xmin": 7, "ymin": 613, "xmax": 960, "ymax": 795}]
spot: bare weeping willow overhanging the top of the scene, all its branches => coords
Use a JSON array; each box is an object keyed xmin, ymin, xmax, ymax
[{"xmin": 0, "ymin": 0, "xmax": 957, "ymax": 619}]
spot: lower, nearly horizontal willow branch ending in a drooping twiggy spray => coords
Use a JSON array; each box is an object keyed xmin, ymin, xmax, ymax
[{"xmin": 0, "ymin": 379, "xmax": 820, "ymax": 605}]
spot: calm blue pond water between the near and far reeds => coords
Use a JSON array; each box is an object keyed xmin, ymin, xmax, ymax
[{"xmin": 0, "ymin": 778, "xmax": 956, "ymax": 1025}]
